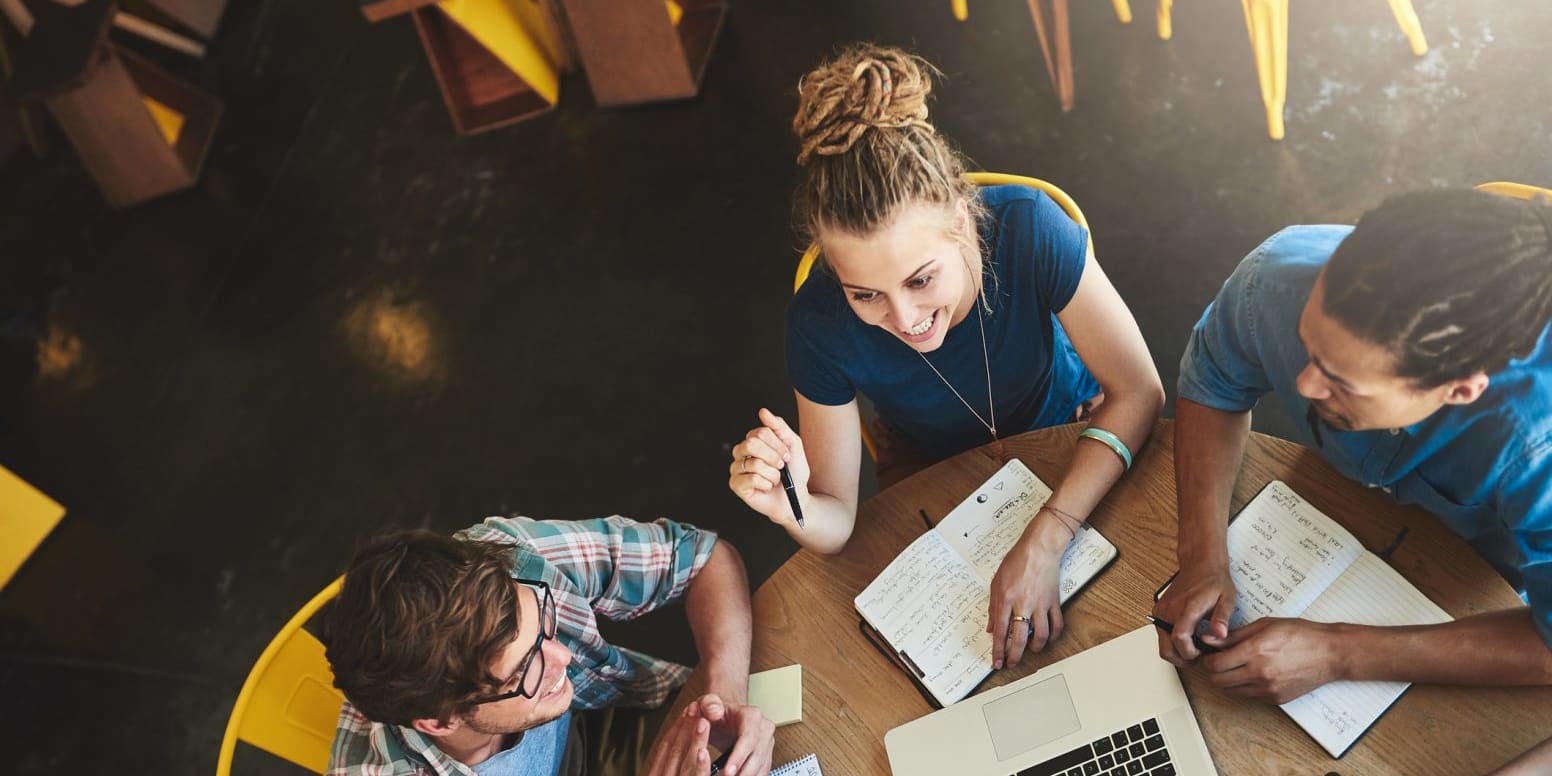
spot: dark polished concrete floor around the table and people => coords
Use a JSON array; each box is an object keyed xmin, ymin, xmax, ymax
[{"xmin": 0, "ymin": 0, "xmax": 1552, "ymax": 773}]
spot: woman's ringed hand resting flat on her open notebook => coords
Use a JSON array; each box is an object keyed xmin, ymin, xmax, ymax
[{"xmin": 986, "ymin": 509, "xmax": 1074, "ymax": 669}]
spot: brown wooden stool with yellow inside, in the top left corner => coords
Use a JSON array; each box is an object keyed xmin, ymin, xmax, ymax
[{"xmin": 11, "ymin": 0, "xmax": 220, "ymax": 208}]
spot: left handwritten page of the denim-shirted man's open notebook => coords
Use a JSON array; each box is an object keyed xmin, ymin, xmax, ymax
[{"xmin": 1228, "ymin": 480, "xmax": 1364, "ymax": 630}]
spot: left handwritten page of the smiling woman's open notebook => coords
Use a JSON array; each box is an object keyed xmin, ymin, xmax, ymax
[{"xmin": 855, "ymin": 531, "xmax": 992, "ymax": 706}]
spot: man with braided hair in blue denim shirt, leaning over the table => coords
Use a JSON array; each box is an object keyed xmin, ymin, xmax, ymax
[{"xmin": 1155, "ymin": 189, "xmax": 1552, "ymax": 703}]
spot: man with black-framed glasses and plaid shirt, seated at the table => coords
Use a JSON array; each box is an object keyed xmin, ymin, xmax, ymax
[{"xmin": 324, "ymin": 517, "xmax": 773, "ymax": 776}]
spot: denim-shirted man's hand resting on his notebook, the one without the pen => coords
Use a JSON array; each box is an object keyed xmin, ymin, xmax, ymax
[{"xmin": 1198, "ymin": 618, "xmax": 1342, "ymax": 703}]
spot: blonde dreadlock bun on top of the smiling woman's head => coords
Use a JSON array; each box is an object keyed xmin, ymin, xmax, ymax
[{"xmin": 792, "ymin": 43, "xmax": 934, "ymax": 165}]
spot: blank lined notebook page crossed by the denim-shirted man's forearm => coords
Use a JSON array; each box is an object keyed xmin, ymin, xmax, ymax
[{"xmin": 1282, "ymin": 553, "xmax": 1451, "ymax": 757}]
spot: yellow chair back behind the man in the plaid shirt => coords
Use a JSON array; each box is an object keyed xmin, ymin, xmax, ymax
[{"xmin": 216, "ymin": 577, "xmax": 345, "ymax": 776}]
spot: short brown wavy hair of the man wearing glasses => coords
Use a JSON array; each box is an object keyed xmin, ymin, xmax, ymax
[{"xmin": 323, "ymin": 529, "xmax": 518, "ymax": 725}]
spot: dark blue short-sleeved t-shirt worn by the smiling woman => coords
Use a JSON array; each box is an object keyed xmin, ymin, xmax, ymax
[{"xmin": 787, "ymin": 186, "xmax": 1099, "ymax": 459}]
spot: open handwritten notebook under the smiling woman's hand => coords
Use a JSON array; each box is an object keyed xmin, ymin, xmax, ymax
[{"xmin": 854, "ymin": 459, "xmax": 1116, "ymax": 706}]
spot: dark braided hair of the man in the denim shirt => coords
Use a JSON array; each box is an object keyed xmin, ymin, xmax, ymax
[{"xmin": 1324, "ymin": 189, "xmax": 1552, "ymax": 388}]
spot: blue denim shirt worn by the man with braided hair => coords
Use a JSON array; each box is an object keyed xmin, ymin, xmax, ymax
[{"xmin": 1180, "ymin": 227, "xmax": 1552, "ymax": 646}]
